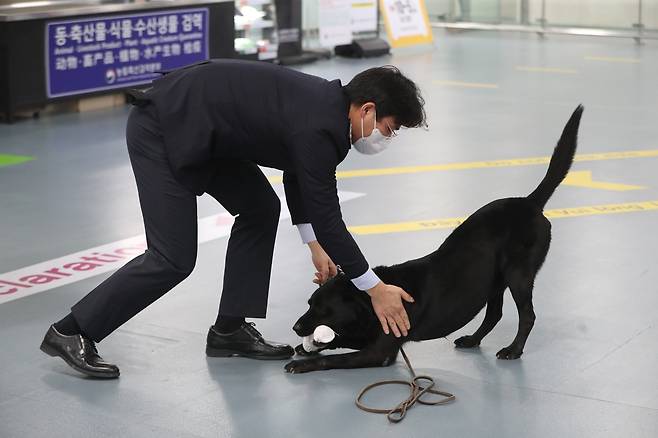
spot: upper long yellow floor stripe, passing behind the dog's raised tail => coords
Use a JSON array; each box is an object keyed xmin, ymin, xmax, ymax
[{"xmin": 268, "ymin": 149, "xmax": 658, "ymax": 183}]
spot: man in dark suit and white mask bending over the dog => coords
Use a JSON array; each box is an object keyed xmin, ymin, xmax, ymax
[{"xmin": 41, "ymin": 60, "xmax": 425, "ymax": 378}]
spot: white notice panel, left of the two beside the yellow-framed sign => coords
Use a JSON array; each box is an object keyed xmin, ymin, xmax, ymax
[{"xmin": 318, "ymin": 0, "xmax": 352, "ymax": 47}]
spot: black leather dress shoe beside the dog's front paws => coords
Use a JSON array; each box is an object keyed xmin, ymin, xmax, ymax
[{"xmin": 206, "ymin": 322, "xmax": 295, "ymax": 360}]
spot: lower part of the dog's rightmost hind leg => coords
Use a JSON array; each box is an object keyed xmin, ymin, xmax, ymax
[{"xmin": 496, "ymin": 270, "xmax": 536, "ymax": 359}]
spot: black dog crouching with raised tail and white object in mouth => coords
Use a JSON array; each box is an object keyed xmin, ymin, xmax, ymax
[{"xmin": 285, "ymin": 106, "xmax": 583, "ymax": 373}]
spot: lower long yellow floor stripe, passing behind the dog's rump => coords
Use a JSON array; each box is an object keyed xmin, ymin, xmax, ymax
[{"xmin": 348, "ymin": 200, "xmax": 658, "ymax": 235}]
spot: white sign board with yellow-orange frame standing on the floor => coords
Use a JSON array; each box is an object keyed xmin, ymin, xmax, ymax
[{"xmin": 381, "ymin": 0, "xmax": 432, "ymax": 47}]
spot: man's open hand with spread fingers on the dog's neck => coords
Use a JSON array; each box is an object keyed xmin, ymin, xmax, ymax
[{"xmin": 368, "ymin": 281, "xmax": 414, "ymax": 338}]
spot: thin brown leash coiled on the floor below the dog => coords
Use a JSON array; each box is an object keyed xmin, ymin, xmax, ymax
[{"xmin": 356, "ymin": 348, "xmax": 455, "ymax": 423}]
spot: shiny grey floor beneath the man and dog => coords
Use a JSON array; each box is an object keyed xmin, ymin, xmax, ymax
[{"xmin": 0, "ymin": 32, "xmax": 658, "ymax": 438}]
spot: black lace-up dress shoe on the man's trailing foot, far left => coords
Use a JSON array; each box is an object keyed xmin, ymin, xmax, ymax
[{"xmin": 41, "ymin": 325, "xmax": 119, "ymax": 379}]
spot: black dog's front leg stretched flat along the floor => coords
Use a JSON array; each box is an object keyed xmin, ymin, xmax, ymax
[{"xmin": 285, "ymin": 335, "xmax": 400, "ymax": 374}]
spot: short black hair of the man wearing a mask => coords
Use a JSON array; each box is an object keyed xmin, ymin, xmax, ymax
[{"xmin": 343, "ymin": 65, "xmax": 427, "ymax": 128}]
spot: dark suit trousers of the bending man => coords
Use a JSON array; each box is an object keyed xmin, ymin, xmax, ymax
[{"xmin": 71, "ymin": 105, "xmax": 281, "ymax": 342}]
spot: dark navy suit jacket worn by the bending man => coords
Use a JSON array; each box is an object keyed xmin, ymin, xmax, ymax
[{"xmin": 133, "ymin": 60, "xmax": 368, "ymax": 278}]
